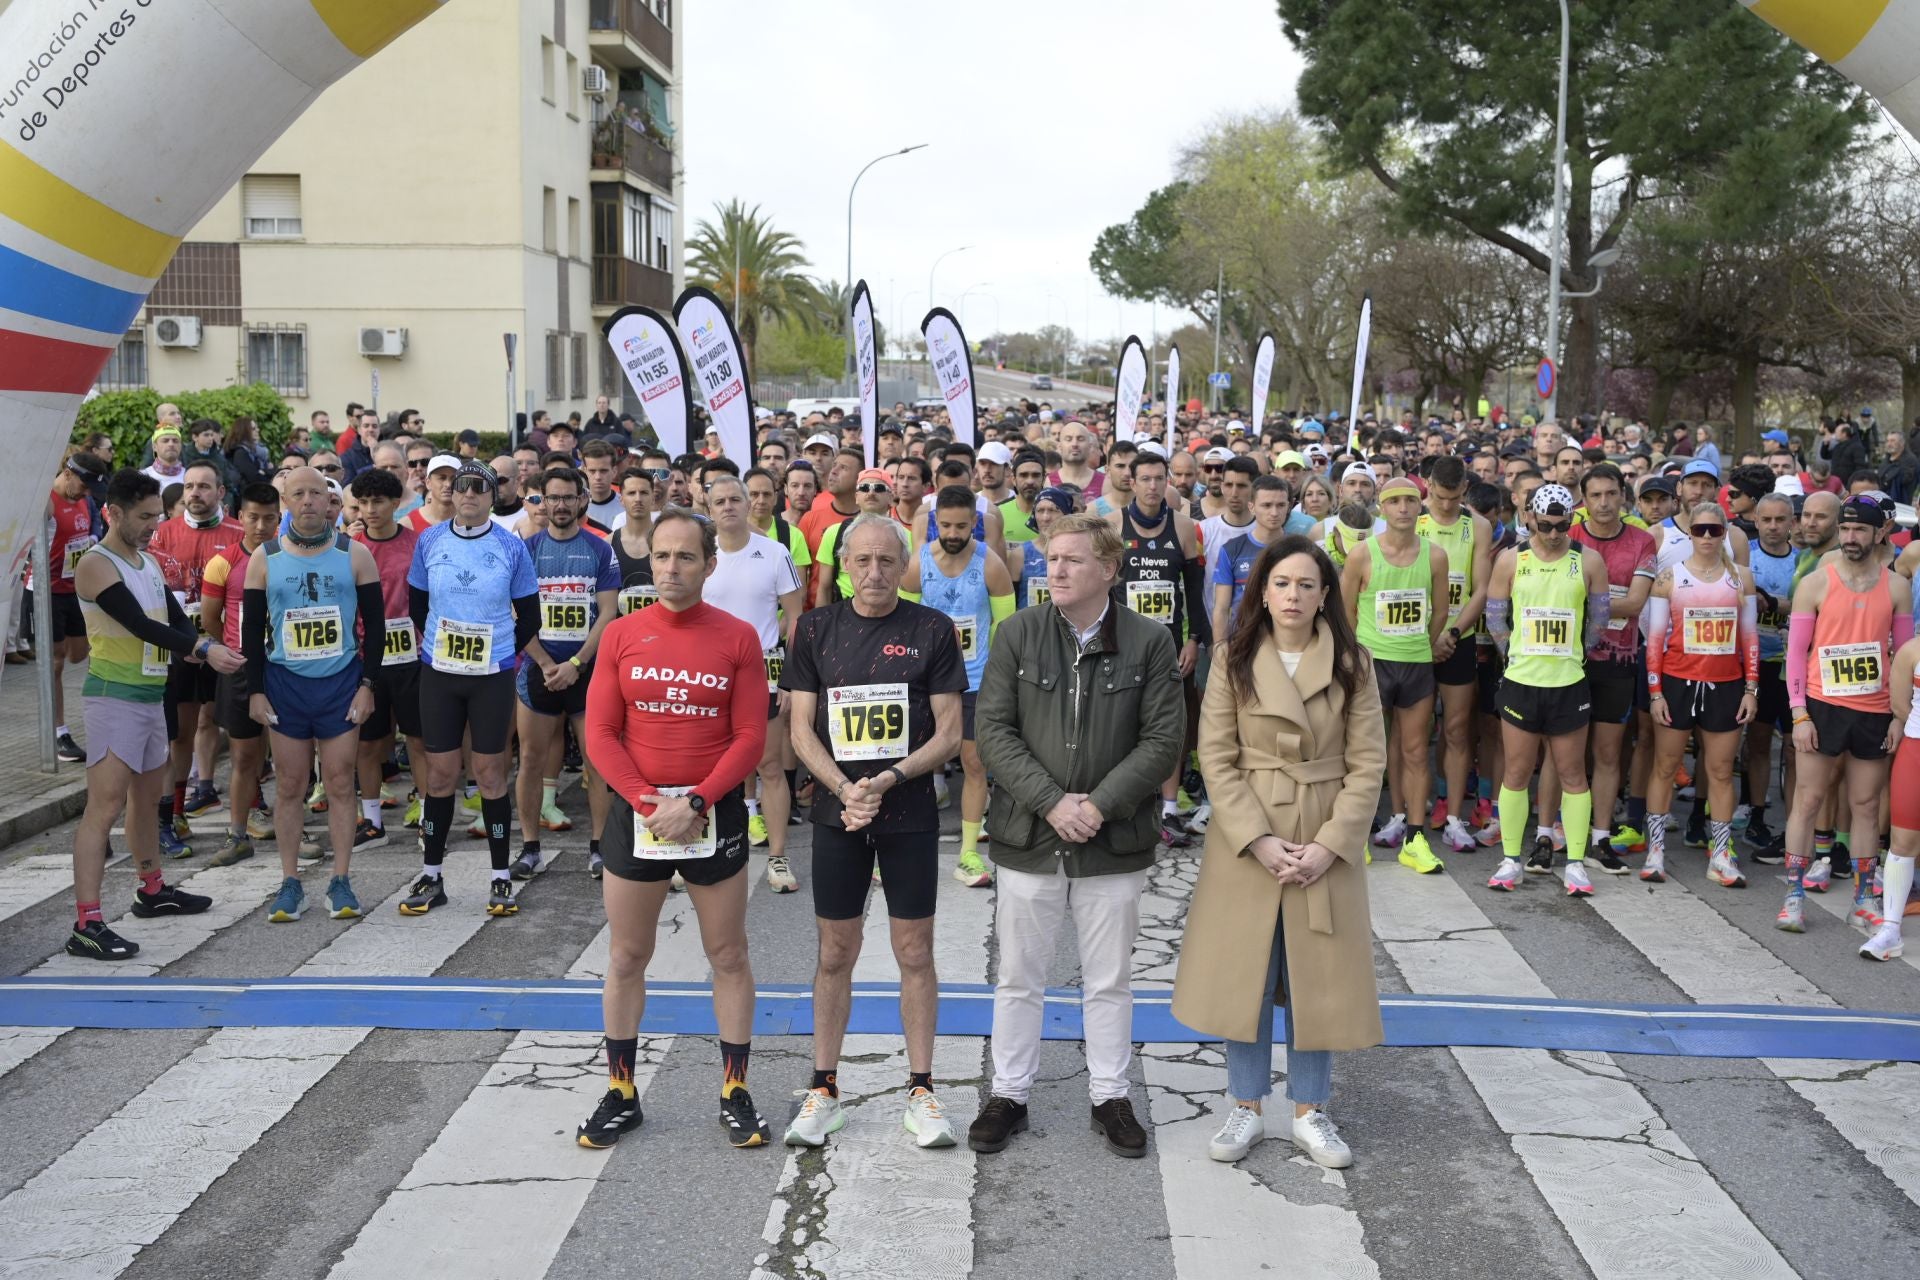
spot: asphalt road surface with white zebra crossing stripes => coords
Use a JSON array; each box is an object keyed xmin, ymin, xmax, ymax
[{"xmin": 0, "ymin": 793, "xmax": 1920, "ymax": 1280}]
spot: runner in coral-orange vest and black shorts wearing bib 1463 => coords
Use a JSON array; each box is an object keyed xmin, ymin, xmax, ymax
[{"xmin": 1774, "ymin": 497, "xmax": 1914, "ymax": 933}]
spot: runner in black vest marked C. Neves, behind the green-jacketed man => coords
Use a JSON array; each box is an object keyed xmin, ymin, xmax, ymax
[{"xmin": 1106, "ymin": 445, "xmax": 1205, "ymax": 848}]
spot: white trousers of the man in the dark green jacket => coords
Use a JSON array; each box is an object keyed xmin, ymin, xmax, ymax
[{"xmin": 993, "ymin": 864, "xmax": 1146, "ymax": 1103}]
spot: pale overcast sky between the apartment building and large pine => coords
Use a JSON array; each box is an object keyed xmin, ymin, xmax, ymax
[{"xmin": 680, "ymin": 0, "xmax": 1300, "ymax": 351}]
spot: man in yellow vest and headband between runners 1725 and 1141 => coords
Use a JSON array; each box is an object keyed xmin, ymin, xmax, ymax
[{"xmin": 1413, "ymin": 457, "xmax": 1494, "ymax": 854}]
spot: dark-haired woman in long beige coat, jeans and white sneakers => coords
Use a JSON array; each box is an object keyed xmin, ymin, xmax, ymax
[{"xmin": 1173, "ymin": 535, "xmax": 1386, "ymax": 1169}]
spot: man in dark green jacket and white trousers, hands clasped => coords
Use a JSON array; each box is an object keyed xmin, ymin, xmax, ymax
[{"xmin": 968, "ymin": 516, "xmax": 1187, "ymax": 1157}]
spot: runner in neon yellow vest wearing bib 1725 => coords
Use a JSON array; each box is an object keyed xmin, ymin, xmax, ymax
[{"xmin": 1340, "ymin": 476, "xmax": 1448, "ymax": 875}]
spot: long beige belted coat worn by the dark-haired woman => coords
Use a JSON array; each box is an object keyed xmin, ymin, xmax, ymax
[{"xmin": 1173, "ymin": 622, "xmax": 1386, "ymax": 1050}]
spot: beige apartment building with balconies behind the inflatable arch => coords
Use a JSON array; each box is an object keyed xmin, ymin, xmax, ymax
[{"xmin": 100, "ymin": 0, "xmax": 685, "ymax": 434}]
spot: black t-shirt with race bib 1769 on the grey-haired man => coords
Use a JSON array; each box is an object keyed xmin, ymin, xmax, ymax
[{"xmin": 780, "ymin": 601, "xmax": 968, "ymax": 833}]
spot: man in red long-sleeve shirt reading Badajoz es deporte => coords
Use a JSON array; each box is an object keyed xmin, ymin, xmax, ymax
[{"xmin": 576, "ymin": 509, "xmax": 768, "ymax": 1148}]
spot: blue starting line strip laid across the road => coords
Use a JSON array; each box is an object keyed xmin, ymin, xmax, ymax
[{"xmin": 0, "ymin": 975, "xmax": 1920, "ymax": 1061}]
